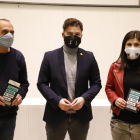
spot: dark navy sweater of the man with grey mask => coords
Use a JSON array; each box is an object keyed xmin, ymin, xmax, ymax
[{"xmin": 0, "ymin": 48, "xmax": 29, "ymax": 119}]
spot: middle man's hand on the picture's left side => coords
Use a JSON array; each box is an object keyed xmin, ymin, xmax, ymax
[{"xmin": 58, "ymin": 99, "xmax": 71, "ymax": 111}]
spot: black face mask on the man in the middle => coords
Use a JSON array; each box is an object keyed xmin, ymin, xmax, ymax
[{"xmin": 64, "ymin": 35, "xmax": 81, "ymax": 48}]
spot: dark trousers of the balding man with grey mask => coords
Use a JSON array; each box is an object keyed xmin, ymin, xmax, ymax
[{"xmin": 0, "ymin": 117, "xmax": 16, "ymax": 140}]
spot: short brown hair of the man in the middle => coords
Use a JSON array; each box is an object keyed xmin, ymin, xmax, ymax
[{"xmin": 63, "ymin": 18, "xmax": 83, "ymax": 31}]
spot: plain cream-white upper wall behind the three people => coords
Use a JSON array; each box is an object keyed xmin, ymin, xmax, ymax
[{"xmin": 0, "ymin": 4, "xmax": 140, "ymax": 99}]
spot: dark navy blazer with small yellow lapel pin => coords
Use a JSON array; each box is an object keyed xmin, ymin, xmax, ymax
[{"xmin": 37, "ymin": 47, "xmax": 101, "ymax": 124}]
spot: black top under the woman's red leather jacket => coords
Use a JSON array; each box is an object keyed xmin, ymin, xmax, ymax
[{"xmin": 114, "ymin": 58, "xmax": 140, "ymax": 123}]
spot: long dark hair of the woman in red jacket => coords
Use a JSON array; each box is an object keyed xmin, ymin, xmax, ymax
[{"xmin": 118, "ymin": 30, "xmax": 140, "ymax": 72}]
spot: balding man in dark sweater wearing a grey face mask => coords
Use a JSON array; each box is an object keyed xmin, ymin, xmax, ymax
[{"xmin": 0, "ymin": 19, "xmax": 29, "ymax": 140}]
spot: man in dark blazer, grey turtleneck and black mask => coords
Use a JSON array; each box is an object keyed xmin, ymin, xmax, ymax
[{"xmin": 37, "ymin": 18, "xmax": 101, "ymax": 140}]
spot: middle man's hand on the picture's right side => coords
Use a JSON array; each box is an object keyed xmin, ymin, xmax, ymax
[{"xmin": 71, "ymin": 97, "xmax": 85, "ymax": 110}]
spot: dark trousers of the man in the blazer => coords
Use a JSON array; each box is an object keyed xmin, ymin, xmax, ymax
[{"xmin": 46, "ymin": 115, "xmax": 89, "ymax": 140}]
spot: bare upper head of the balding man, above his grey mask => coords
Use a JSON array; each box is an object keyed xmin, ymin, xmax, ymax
[{"xmin": 0, "ymin": 19, "xmax": 14, "ymax": 36}]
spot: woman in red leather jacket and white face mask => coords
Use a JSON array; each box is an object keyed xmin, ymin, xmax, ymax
[{"xmin": 105, "ymin": 31, "xmax": 140, "ymax": 140}]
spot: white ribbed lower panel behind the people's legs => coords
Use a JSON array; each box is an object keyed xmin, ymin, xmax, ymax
[{"xmin": 14, "ymin": 105, "xmax": 112, "ymax": 140}]
